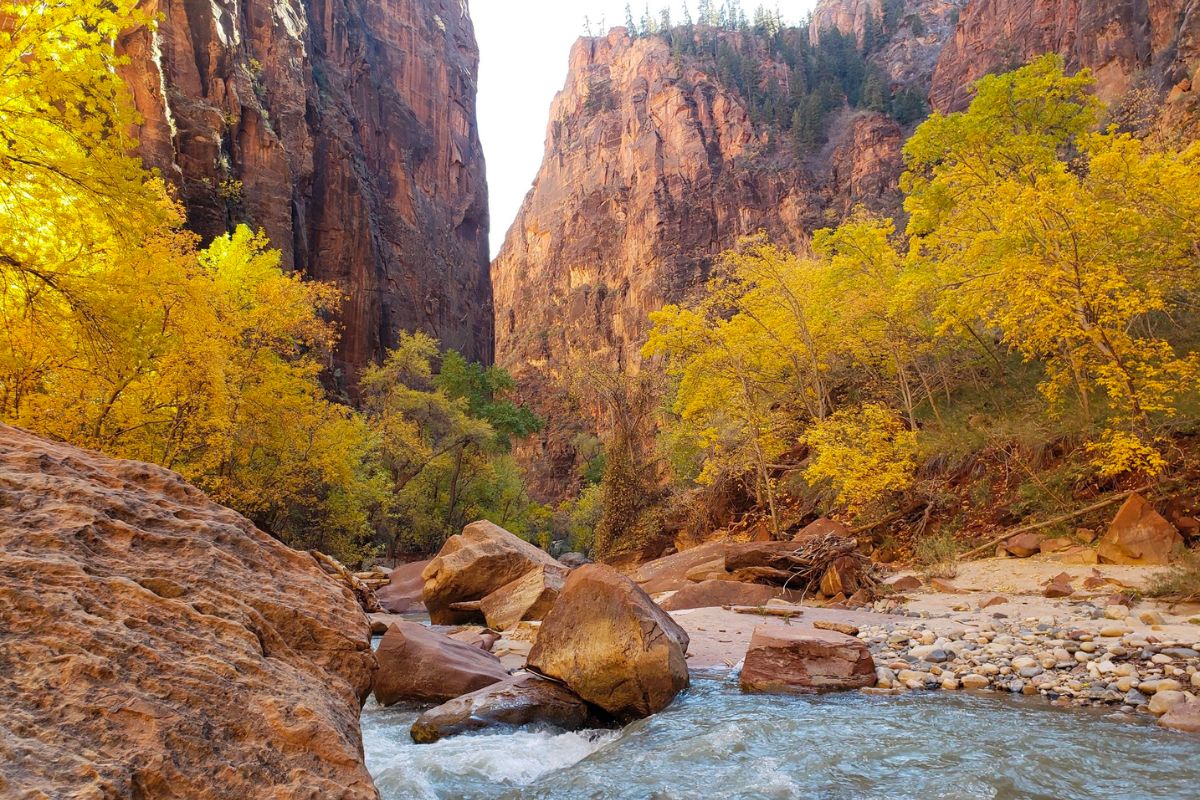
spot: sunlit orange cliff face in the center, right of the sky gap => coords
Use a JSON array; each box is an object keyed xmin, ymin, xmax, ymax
[{"xmin": 492, "ymin": 29, "xmax": 902, "ymax": 498}]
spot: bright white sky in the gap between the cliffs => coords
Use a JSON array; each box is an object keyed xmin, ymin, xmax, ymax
[{"xmin": 470, "ymin": 0, "xmax": 816, "ymax": 257}]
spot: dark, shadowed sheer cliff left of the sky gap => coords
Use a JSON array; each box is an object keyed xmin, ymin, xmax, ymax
[{"xmin": 121, "ymin": 0, "xmax": 492, "ymax": 385}]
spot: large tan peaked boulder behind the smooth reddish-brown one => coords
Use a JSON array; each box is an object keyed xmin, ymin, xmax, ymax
[{"xmin": 421, "ymin": 521, "xmax": 566, "ymax": 625}]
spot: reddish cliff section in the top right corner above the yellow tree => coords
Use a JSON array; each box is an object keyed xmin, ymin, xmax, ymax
[{"xmin": 930, "ymin": 0, "xmax": 1200, "ymax": 120}]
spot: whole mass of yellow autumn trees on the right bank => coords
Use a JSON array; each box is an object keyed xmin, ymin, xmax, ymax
[{"xmin": 644, "ymin": 56, "xmax": 1200, "ymax": 517}]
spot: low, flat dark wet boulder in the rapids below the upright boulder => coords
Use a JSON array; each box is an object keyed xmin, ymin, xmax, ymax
[{"xmin": 410, "ymin": 673, "xmax": 601, "ymax": 745}]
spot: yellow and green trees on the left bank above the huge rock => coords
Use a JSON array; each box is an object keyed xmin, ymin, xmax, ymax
[{"xmin": 0, "ymin": 0, "xmax": 546, "ymax": 564}]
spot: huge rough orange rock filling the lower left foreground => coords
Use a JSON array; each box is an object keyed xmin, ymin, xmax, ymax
[{"xmin": 0, "ymin": 426, "xmax": 378, "ymax": 800}]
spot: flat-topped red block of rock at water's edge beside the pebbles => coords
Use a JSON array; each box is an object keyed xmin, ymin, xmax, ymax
[{"xmin": 740, "ymin": 625, "xmax": 876, "ymax": 694}]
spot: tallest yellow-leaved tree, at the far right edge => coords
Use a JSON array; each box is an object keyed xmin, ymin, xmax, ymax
[{"xmin": 905, "ymin": 56, "xmax": 1200, "ymax": 476}]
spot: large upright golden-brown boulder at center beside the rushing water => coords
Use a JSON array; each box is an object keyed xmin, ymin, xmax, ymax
[{"xmin": 529, "ymin": 564, "xmax": 688, "ymax": 720}]
